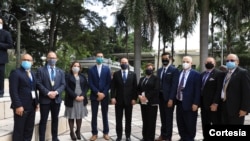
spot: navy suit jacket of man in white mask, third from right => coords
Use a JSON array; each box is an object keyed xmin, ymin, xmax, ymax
[{"xmin": 182, "ymin": 69, "xmax": 201, "ymax": 111}]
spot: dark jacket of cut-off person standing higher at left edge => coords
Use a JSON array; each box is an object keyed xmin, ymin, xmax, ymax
[{"xmin": 0, "ymin": 29, "xmax": 13, "ymax": 64}]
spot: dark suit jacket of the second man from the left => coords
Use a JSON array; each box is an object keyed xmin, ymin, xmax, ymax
[{"xmin": 37, "ymin": 66, "xmax": 66, "ymax": 104}]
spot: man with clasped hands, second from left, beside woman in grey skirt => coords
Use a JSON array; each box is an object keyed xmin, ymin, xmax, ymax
[{"xmin": 37, "ymin": 51, "xmax": 66, "ymax": 141}]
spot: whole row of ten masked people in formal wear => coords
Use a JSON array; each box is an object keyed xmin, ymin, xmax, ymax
[{"xmin": 6, "ymin": 48, "xmax": 250, "ymax": 141}]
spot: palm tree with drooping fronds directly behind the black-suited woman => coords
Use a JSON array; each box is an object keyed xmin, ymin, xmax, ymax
[{"xmin": 117, "ymin": 0, "xmax": 154, "ymax": 80}]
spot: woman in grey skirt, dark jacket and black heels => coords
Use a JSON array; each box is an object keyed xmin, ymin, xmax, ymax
[{"xmin": 64, "ymin": 61, "xmax": 88, "ymax": 140}]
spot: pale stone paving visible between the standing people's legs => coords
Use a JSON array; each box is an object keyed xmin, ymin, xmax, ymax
[{"xmin": 55, "ymin": 104, "xmax": 202, "ymax": 141}]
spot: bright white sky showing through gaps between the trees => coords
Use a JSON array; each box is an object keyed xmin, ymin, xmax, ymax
[{"xmin": 85, "ymin": 1, "xmax": 200, "ymax": 50}]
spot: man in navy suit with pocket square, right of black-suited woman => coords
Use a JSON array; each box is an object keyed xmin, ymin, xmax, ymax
[{"xmin": 156, "ymin": 52, "xmax": 179, "ymax": 141}]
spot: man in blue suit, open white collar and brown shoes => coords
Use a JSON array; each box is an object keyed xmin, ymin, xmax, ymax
[{"xmin": 88, "ymin": 53, "xmax": 111, "ymax": 141}]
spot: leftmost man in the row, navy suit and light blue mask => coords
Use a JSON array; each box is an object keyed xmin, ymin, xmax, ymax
[{"xmin": 9, "ymin": 54, "xmax": 38, "ymax": 141}]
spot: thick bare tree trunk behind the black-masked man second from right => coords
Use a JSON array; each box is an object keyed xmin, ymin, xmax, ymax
[{"xmin": 200, "ymin": 0, "xmax": 209, "ymax": 71}]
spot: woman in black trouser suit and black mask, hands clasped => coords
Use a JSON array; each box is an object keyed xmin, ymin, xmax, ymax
[{"xmin": 138, "ymin": 63, "xmax": 159, "ymax": 141}]
